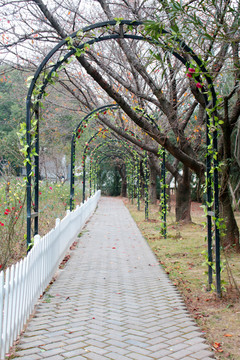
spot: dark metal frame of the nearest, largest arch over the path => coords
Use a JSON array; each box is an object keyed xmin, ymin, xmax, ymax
[{"xmin": 26, "ymin": 20, "xmax": 221, "ymax": 295}]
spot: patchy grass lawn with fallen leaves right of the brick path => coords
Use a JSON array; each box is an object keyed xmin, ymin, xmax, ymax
[{"xmin": 124, "ymin": 195, "xmax": 240, "ymax": 360}]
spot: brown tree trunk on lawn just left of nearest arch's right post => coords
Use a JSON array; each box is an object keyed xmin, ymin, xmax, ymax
[{"xmin": 175, "ymin": 166, "xmax": 192, "ymax": 223}]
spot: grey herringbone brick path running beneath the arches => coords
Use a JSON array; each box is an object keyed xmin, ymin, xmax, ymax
[{"xmin": 16, "ymin": 198, "xmax": 215, "ymax": 360}]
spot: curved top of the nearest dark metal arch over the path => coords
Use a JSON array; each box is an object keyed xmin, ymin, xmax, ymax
[{"xmin": 27, "ymin": 20, "xmax": 215, "ymax": 106}]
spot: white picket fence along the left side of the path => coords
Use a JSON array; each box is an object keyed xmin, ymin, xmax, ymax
[{"xmin": 0, "ymin": 191, "xmax": 101, "ymax": 360}]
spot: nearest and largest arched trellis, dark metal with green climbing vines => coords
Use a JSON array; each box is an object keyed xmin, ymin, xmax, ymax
[{"xmin": 26, "ymin": 20, "xmax": 221, "ymax": 295}]
